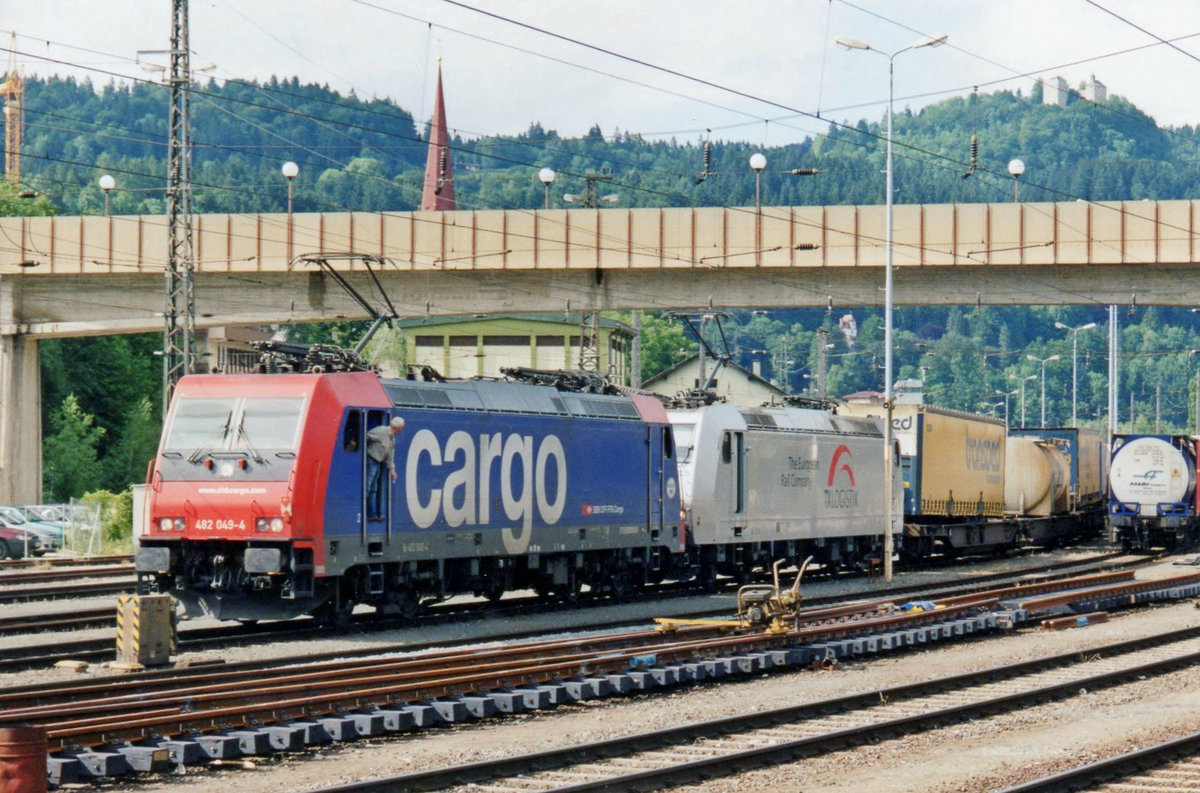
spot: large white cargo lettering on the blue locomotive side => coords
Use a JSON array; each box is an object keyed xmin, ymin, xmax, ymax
[{"xmin": 404, "ymin": 429, "xmax": 566, "ymax": 553}]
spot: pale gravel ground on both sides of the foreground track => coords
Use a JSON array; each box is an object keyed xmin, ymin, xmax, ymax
[{"xmin": 35, "ymin": 549, "xmax": 1200, "ymax": 793}]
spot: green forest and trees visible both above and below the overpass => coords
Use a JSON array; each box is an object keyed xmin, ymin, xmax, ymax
[{"xmin": 11, "ymin": 78, "xmax": 1200, "ymax": 500}]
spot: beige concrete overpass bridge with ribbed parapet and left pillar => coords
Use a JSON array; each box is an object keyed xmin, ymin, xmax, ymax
[{"xmin": 0, "ymin": 194, "xmax": 1200, "ymax": 503}]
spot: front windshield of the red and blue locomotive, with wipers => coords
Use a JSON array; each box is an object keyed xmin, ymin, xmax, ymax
[{"xmin": 162, "ymin": 397, "xmax": 304, "ymax": 453}]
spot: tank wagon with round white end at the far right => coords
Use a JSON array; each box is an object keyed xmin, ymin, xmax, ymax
[{"xmin": 1108, "ymin": 434, "xmax": 1198, "ymax": 549}]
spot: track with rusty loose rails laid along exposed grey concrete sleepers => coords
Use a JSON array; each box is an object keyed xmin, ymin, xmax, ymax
[{"xmin": 11, "ymin": 573, "xmax": 1200, "ymax": 789}]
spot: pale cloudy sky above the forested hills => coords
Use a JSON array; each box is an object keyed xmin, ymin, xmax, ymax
[{"xmin": 7, "ymin": 0, "xmax": 1200, "ymax": 146}]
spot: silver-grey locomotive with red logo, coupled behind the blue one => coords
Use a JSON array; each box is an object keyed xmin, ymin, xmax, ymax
[{"xmin": 668, "ymin": 404, "xmax": 902, "ymax": 579}]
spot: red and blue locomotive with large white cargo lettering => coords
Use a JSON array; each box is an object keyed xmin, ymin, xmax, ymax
[{"xmin": 136, "ymin": 371, "xmax": 684, "ymax": 620}]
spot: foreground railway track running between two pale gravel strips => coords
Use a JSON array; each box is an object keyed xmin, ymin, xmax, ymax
[{"xmin": 319, "ymin": 627, "xmax": 1200, "ymax": 793}]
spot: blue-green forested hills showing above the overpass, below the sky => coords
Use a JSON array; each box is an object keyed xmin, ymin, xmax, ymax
[{"xmin": 24, "ymin": 78, "xmax": 1200, "ymax": 214}]
